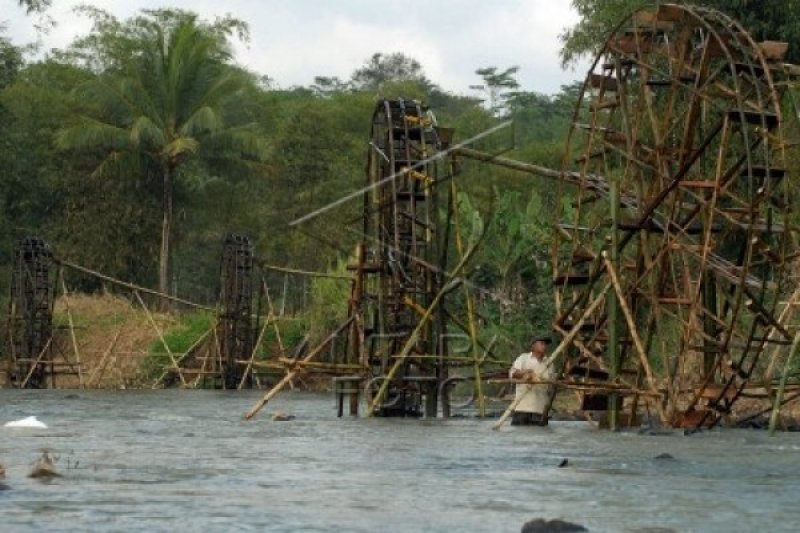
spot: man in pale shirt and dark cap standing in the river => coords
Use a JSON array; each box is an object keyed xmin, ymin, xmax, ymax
[{"xmin": 508, "ymin": 335, "xmax": 553, "ymax": 426}]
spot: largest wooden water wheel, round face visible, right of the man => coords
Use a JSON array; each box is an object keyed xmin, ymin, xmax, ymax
[{"xmin": 554, "ymin": 5, "xmax": 791, "ymax": 427}]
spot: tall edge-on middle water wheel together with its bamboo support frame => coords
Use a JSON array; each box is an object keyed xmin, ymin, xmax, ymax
[{"xmin": 332, "ymin": 99, "xmax": 506, "ymax": 416}]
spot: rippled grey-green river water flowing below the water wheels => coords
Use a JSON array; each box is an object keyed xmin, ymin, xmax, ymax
[{"xmin": 0, "ymin": 389, "xmax": 800, "ymax": 532}]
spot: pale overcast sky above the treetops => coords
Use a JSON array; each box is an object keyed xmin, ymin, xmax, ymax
[{"xmin": 0, "ymin": 0, "xmax": 588, "ymax": 94}]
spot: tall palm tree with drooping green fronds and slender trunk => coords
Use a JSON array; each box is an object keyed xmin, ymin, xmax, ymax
[{"xmin": 57, "ymin": 16, "xmax": 266, "ymax": 293}]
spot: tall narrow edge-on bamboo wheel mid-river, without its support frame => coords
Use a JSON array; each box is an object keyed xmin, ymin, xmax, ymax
[{"xmin": 359, "ymin": 99, "xmax": 447, "ymax": 415}]
